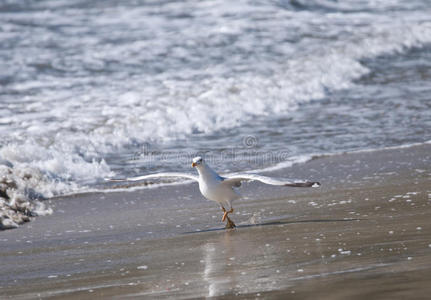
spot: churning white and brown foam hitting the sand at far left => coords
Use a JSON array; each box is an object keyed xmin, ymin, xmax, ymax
[{"xmin": 0, "ymin": 143, "xmax": 111, "ymax": 230}]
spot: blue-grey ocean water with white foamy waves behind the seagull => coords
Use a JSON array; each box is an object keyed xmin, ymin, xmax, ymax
[{"xmin": 0, "ymin": 0, "xmax": 431, "ymax": 197}]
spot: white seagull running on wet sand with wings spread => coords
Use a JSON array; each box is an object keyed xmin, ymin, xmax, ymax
[{"xmin": 106, "ymin": 156, "xmax": 320, "ymax": 229}]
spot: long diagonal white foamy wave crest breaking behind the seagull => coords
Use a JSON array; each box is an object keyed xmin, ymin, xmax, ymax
[{"xmin": 96, "ymin": 16, "xmax": 431, "ymax": 147}]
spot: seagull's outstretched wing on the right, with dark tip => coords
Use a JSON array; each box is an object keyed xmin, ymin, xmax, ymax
[{"xmin": 223, "ymin": 174, "xmax": 320, "ymax": 187}]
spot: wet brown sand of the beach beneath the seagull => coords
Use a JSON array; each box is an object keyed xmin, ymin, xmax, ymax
[{"xmin": 0, "ymin": 144, "xmax": 431, "ymax": 299}]
